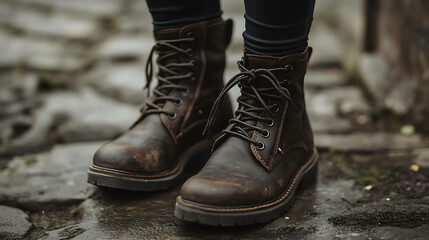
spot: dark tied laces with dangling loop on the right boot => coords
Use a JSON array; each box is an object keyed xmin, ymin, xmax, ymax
[{"xmin": 203, "ymin": 61, "xmax": 296, "ymax": 147}]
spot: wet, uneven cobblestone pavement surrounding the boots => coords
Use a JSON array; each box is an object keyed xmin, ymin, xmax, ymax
[{"xmin": 0, "ymin": 0, "xmax": 429, "ymax": 239}]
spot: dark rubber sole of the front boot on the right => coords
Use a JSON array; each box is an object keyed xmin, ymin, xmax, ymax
[{"xmin": 174, "ymin": 152, "xmax": 318, "ymax": 227}]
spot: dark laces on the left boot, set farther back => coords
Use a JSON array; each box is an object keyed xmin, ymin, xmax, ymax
[{"xmin": 140, "ymin": 37, "xmax": 195, "ymax": 117}]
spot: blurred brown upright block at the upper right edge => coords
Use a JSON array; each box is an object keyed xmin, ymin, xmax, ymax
[{"xmin": 367, "ymin": 0, "xmax": 429, "ymax": 122}]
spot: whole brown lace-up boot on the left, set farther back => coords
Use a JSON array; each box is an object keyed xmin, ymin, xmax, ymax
[{"xmin": 88, "ymin": 18, "xmax": 232, "ymax": 191}]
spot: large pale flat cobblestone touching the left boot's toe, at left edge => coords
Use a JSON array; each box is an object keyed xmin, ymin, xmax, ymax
[{"xmin": 0, "ymin": 143, "xmax": 101, "ymax": 209}]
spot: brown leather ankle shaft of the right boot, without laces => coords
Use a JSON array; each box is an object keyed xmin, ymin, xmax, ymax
[{"xmin": 243, "ymin": 48, "xmax": 314, "ymax": 170}]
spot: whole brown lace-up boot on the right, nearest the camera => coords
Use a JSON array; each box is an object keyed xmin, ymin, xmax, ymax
[{"xmin": 175, "ymin": 48, "xmax": 317, "ymax": 226}]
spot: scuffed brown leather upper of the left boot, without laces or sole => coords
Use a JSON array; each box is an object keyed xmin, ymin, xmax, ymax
[{"xmin": 89, "ymin": 18, "xmax": 232, "ymax": 177}]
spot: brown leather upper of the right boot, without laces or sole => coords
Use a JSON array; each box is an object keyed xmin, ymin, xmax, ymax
[{"xmin": 180, "ymin": 48, "xmax": 314, "ymax": 209}]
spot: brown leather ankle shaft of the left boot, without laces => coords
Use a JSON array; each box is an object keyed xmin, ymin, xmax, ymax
[{"xmin": 148, "ymin": 18, "xmax": 232, "ymax": 142}]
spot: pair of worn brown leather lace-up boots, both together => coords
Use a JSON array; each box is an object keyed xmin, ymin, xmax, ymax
[{"xmin": 88, "ymin": 18, "xmax": 317, "ymax": 226}]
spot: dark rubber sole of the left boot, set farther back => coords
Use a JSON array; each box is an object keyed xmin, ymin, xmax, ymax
[{"xmin": 88, "ymin": 141, "xmax": 211, "ymax": 192}]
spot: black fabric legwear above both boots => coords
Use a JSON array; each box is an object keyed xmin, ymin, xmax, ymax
[{"xmin": 146, "ymin": 0, "xmax": 315, "ymax": 56}]
